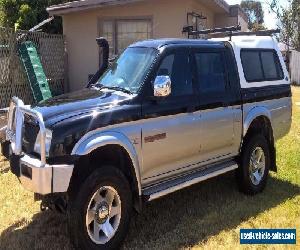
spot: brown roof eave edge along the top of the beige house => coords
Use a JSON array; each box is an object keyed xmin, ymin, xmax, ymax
[{"xmin": 47, "ymin": 0, "xmax": 240, "ymax": 15}]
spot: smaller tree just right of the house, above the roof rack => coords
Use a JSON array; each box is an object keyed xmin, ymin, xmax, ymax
[{"xmin": 241, "ymin": 0, "xmax": 265, "ymax": 31}]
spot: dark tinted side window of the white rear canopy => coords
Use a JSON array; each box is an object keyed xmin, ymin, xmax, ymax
[{"xmin": 241, "ymin": 50, "xmax": 283, "ymax": 82}]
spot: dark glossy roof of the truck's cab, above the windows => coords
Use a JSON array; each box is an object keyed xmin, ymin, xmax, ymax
[{"xmin": 130, "ymin": 38, "xmax": 224, "ymax": 49}]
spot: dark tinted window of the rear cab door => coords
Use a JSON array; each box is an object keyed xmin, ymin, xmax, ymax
[{"xmin": 195, "ymin": 52, "xmax": 226, "ymax": 93}]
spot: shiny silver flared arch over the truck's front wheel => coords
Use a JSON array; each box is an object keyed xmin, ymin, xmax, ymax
[{"xmin": 72, "ymin": 132, "xmax": 142, "ymax": 195}]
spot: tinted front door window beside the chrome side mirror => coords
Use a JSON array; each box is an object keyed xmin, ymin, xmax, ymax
[{"xmin": 157, "ymin": 51, "xmax": 193, "ymax": 96}]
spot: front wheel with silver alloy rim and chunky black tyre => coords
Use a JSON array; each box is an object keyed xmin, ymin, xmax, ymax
[{"xmin": 68, "ymin": 166, "xmax": 132, "ymax": 250}]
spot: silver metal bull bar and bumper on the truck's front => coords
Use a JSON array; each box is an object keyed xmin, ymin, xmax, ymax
[{"xmin": 2, "ymin": 98, "xmax": 74, "ymax": 195}]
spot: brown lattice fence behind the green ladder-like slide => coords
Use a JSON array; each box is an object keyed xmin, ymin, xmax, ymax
[{"xmin": 0, "ymin": 27, "xmax": 66, "ymax": 108}]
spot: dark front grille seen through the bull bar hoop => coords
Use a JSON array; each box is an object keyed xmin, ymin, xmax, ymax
[{"xmin": 22, "ymin": 114, "xmax": 40, "ymax": 154}]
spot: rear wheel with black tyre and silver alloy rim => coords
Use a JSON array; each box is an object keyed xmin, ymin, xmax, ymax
[{"xmin": 236, "ymin": 134, "xmax": 271, "ymax": 195}]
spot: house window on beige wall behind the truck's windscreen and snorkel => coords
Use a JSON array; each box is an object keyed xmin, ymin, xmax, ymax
[{"xmin": 100, "ymin": 19, "xmax": 152, "ymax": 56}]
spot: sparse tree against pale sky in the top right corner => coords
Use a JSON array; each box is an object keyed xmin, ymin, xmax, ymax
[{"xmin": 268, "ymin": 0, "xmax": 300, "ymax": 51}]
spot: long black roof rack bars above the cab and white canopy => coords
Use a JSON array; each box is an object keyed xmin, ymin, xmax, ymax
[{"xmin": 182, "ymin": 25, "xmax": 280, "ymax": 40}]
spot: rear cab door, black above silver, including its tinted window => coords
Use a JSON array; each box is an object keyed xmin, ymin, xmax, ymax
[{"xmin": 193, "ymin": 49, "xmax": 236, "ymax": 163}]
